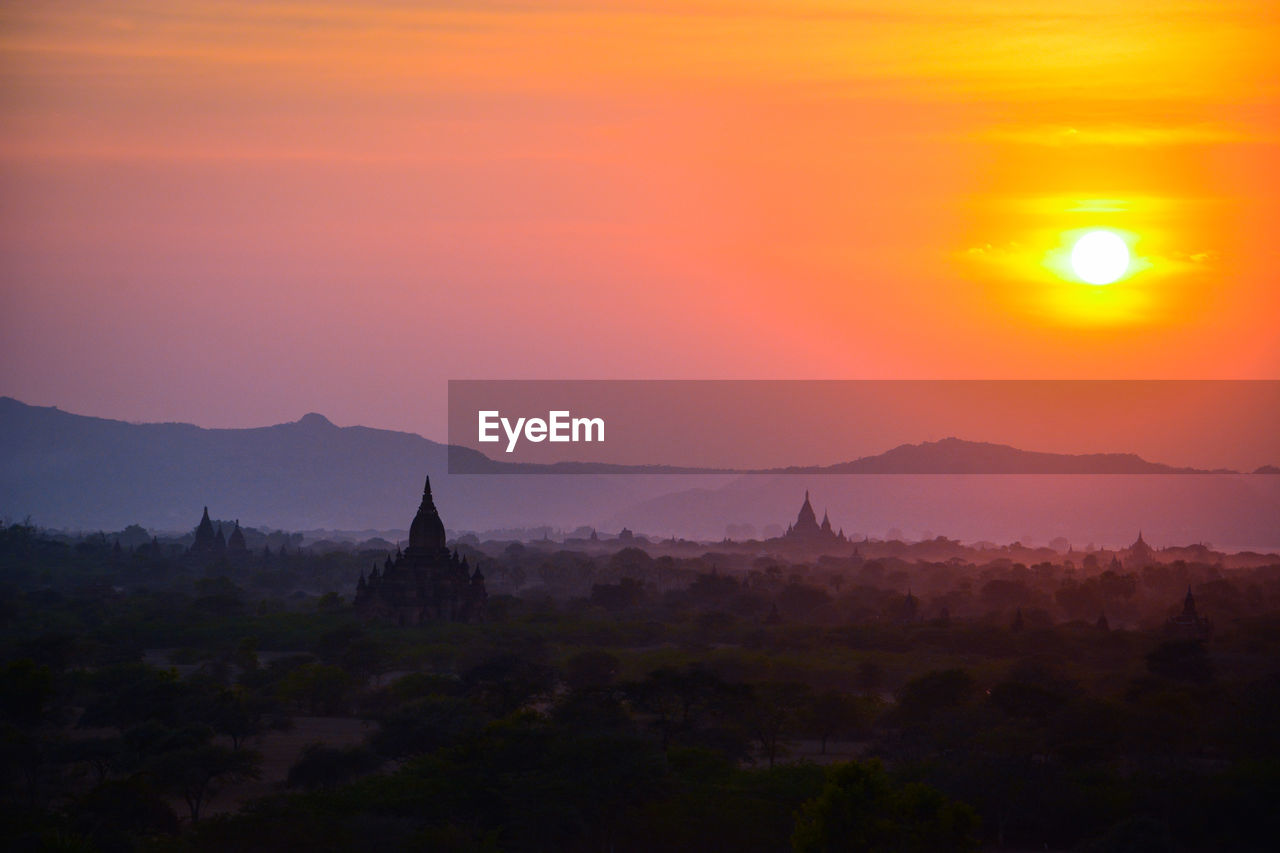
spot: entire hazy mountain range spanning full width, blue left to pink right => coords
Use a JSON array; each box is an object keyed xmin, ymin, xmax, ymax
[{"xmin": 0, "ymin": 397, "xmax": 1280, "ymax": 548}]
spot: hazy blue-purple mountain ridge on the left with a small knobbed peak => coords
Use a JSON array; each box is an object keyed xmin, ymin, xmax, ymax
[{"xmin": 0, "ymin": 397, "xmax": 701, "ymax": 530}]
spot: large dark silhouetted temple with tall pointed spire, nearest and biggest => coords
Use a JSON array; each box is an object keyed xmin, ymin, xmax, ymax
[{"xmin": 356, "ymin": 478, "xmax": 489, "ymax": 625}]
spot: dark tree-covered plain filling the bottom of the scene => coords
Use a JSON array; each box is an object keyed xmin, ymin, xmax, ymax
[{"xmin": 0, "ymin": 517, "xmax": 1280, "ymax": 850}]
